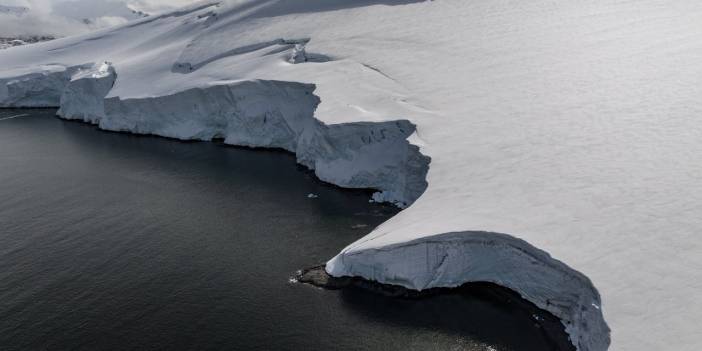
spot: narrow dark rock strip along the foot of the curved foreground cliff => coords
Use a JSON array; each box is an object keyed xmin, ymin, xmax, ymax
[{"xmin": 294, "ymin": 265, "xmax": 575, "ymax": 351}]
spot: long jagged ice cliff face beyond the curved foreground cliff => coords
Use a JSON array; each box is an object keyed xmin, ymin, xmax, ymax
[{"xmin": 13, "ymin": 62, "xmax": 430, "ymax": 207}]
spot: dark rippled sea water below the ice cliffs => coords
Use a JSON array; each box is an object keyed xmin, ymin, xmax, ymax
[{"xmin": 0, "ymin": 110, "xmax": 568, "ymax": 351}]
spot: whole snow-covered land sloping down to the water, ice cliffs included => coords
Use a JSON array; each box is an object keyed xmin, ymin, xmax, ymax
[{"xmin": 0, "ymin": 0, "xmax": 702, "ymax": 351}]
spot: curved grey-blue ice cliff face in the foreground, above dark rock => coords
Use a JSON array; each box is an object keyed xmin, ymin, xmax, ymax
[{"xmin": 326, "ymin": 232, "xmax": 610, "ymax": 350}]
